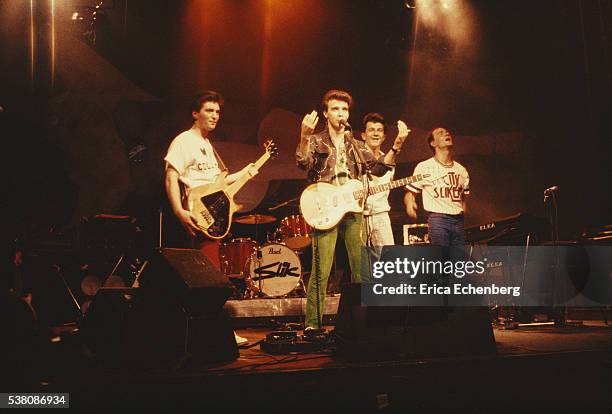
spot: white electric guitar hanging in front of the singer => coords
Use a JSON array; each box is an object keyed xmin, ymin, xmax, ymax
[{"xmin": 300, "ymin": 174, "xmax": 429, "ymax": 230}]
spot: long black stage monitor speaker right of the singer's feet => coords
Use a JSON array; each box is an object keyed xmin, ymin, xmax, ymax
[{"xmin": 335, "ymin": 283, "xmax": 495, "ymax": 361}]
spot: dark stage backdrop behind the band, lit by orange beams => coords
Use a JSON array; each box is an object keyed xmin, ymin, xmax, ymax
[{"xmin": 0, "ymin": 0, "xmax": 611, "ymax": 246}]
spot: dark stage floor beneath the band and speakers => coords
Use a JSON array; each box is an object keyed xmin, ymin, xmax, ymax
[{"xmin": 13, "ymin": 321, "xmax": 612, "ymax": 413}]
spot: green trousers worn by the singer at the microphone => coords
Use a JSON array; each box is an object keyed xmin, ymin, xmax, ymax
[{"xmin": 306, "ymin": 213, "xmax": 364, "ymax": 328}]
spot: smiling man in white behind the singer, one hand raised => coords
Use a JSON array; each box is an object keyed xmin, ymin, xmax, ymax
[{"xmin": 361, "ymin": 112, "xmax": 410, "ymax": 246}]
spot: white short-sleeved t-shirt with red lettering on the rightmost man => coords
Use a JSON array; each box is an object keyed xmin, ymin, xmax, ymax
[{"xmin": 406, "ymin": 157, "xmax": 470, "ymax": 214}]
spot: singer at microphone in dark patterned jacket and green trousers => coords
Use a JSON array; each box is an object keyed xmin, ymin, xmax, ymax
[{"xmin": 295, "ymin": 89, "xmax": 405, "ymax": 332}]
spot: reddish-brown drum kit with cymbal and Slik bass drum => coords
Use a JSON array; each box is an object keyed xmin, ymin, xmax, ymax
[{"xmin": 219, "ymin": 214, "xmax": 312, "ymax": 299}]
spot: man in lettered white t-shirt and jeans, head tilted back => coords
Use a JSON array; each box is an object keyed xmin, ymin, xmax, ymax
[{"xmin": 404, "ymin": 128, "xmax": 470, "ymax": 246}]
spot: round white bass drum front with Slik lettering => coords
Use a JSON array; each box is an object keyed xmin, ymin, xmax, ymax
[{"xmin": 249, "ymin": 244, "xmax": 302, "ymax": 297}]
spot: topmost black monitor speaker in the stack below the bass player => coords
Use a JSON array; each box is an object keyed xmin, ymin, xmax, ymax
[{"xmin": 139, "ymin": 248, "xmax": 233, "ymax": 317}]
